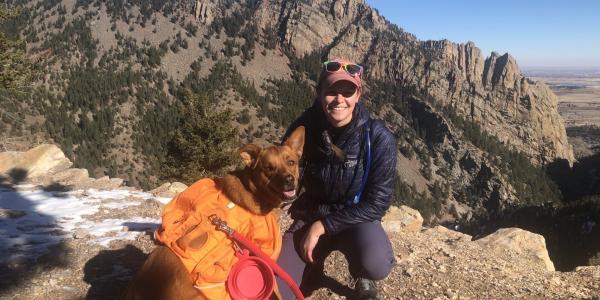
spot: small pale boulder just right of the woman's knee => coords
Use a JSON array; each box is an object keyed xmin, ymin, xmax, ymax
[{"xmin": 382, "ymin": 205, "xmax": 423, "ymax": 233}]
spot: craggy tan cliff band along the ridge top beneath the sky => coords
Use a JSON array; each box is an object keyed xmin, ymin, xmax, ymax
[{"xmin": 229, "ymin": 0, "xmax": 573, "ymax": 163}]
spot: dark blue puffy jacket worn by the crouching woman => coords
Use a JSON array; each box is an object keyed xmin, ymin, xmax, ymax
[{"xmin": 286, "ymin": 102, "xmax": 396, "ymax": 233}]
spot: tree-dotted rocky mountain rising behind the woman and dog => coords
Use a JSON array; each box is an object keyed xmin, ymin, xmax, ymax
[{"xmin": 0, "ymin": 0, "xmax": 573, "ymax": 227}]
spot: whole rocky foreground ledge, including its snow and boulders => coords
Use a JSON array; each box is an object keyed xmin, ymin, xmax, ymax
[{"xmin": 0, "ymin": 145, "xmax": 600, "ymax": 299}]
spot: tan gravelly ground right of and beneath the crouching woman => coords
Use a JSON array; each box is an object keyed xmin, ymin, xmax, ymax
[{"xmin": 313, "ymin": 227, "xmax": 600, "ymax": 299}]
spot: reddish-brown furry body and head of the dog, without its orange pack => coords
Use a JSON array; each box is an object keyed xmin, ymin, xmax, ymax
[{"xmin": 124, "ymin": 127, "xmax": 304, "ymax": 300}]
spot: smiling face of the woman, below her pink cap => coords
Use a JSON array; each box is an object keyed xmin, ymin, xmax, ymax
[{"xmin": 320, "ymin": 80, "xmax": 360, "ymax": 127}]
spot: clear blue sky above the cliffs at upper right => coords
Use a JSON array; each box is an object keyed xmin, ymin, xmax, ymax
[{"xmin": 367, "ymin": 0, "xmax": 600, "ymax": 67}]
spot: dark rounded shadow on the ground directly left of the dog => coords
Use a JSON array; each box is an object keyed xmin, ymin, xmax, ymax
[{"xmin": 83, "ymin": 245, "xmax": 147, "ymax": 299}]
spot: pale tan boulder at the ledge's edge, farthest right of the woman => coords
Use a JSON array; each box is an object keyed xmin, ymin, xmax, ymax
[{"xmin": 476, "ymin": 228, "xmax": 555, "ymax": 271}]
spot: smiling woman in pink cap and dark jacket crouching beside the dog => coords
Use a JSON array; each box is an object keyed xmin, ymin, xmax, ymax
[{"xmin": 278, "ymin": 59, "xmax": 396, "ymax": 299}]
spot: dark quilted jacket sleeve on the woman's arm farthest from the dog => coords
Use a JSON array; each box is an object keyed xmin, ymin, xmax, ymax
[{"xmin": 322, "ymin": 120, "xmax": 396, "ymax": 233}]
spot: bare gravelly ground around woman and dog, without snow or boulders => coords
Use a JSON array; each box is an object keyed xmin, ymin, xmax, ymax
[{"xmin": 0, "ymin": 184, "xmax": 600, "ymax": 299}]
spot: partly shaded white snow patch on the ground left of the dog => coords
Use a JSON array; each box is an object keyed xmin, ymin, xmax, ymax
[{"xmin": 0, "ymin": 185, "xmax": 163, "ymax": 262}]
